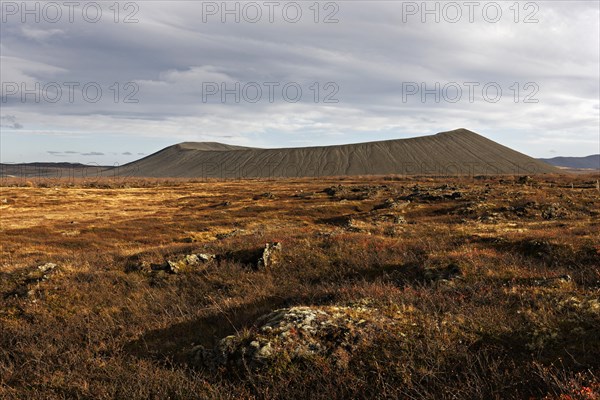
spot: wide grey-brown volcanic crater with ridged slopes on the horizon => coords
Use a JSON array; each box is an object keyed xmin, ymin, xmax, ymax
[{"xmin": 119, "ymin": 129, "xmax": 560, "ymax": 178}]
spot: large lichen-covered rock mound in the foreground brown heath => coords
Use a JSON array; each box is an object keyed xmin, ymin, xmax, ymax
[{"xmin": 191, "ymin": 305, "xmax": 395, "ymax": 369}]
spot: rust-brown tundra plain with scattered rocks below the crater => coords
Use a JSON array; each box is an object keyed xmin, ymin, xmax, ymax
[{"xmin": 0, "ymin": 175, "xmax": 600, "ymax": 400}]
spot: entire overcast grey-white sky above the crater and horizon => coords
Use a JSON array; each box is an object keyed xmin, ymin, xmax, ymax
[{"xmin": 0, "ymin": 0, "xmax": 600, "ymax": 164}]
